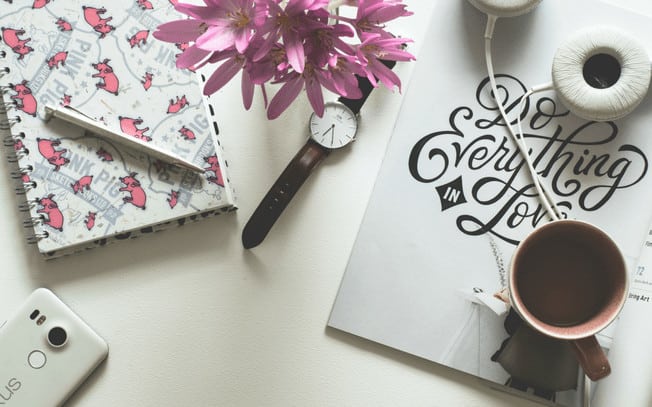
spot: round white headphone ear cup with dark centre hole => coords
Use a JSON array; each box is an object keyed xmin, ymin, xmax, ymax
[{"xmin": 552, "ymin": 26, "xmax": 650, "ymax": 121}]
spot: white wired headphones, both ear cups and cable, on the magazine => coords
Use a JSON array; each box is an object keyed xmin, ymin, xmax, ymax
[{"xmin": 469, "ymin": 0, "xmax": 651, "ymax": 226}]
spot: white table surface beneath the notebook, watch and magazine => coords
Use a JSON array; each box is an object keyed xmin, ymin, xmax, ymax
[{"xmin": 0, "ymin": 0, "xmax": 652, "ymax": 407}]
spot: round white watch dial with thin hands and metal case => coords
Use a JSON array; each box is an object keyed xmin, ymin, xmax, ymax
[{"xmin": 309, "ymin": 103, "xmax": 358, "ymax": 148}]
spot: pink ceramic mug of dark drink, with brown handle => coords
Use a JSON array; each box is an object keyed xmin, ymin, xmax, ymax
[{"xmin": 509, "ymin": 220, "xmax": 628, "ymax": 380}]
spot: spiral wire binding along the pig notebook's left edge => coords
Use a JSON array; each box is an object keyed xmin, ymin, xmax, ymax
[{"xmin": 0, "ymin": 51, "xmax": 49, "ymax": 244}]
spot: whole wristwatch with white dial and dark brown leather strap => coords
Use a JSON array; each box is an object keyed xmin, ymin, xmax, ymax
[{"xmin": 242, "ymin": 61, "xmax": 396, "ymax": 249}]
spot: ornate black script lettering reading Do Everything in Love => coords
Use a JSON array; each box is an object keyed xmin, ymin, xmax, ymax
[{"xmin": 407, "ymin": 75, "xmax": 648, "ymax": 244}]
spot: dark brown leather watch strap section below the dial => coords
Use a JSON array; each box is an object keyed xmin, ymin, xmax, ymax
[{"xmin": 242, "ymin": 139, "xmax": 330, "ymax": 249}]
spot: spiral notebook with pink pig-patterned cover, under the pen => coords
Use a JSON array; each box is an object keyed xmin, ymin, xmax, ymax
[{"xmin": 0, "ymin": 0, "xmax": 236, "ymax": 258}]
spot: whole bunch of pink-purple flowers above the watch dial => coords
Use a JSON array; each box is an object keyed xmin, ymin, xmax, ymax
[{"xmin": 154, "ymin": 0, "xmax": 414, "ymax": 119}]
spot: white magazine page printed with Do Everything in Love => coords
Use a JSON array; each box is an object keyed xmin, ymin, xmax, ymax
[{"xmin": 329, "ymin": 0, "xmax": 652, "ymax": 406}]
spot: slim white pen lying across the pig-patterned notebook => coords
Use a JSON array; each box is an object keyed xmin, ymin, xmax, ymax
[{"xmin": 45, "ymin": 105, "xmax": 206, "ymax": 174}]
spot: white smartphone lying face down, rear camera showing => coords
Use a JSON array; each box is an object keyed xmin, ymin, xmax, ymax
[{"xmin": 0, "ymin": 288, "xmax": 109, "ymax": 407}]
